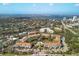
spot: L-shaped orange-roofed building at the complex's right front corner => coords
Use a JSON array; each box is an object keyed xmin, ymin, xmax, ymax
[{"xmin": 44, "ymin": 35, "xmax": 61, "ymax": 48}]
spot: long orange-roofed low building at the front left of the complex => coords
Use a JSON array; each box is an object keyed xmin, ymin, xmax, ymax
[{"xmin": 13, "ymin": 42, "xmax": 32, "ymax": 52}]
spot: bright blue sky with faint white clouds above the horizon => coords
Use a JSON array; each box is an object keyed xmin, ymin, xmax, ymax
[{"xmin": 0, "ymin": 3, "xmax": 79, "ymax": 15}]
